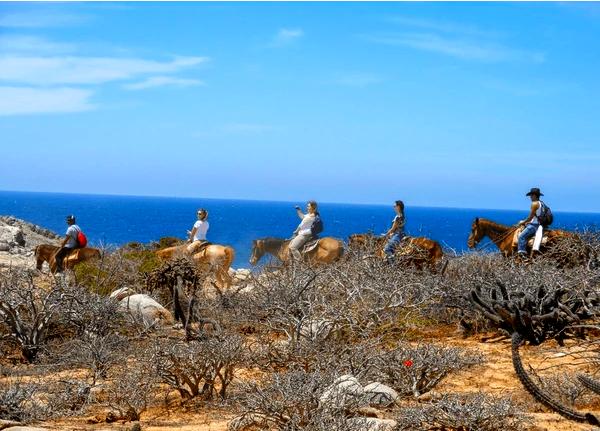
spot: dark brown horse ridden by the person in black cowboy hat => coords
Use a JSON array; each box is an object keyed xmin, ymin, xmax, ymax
[{"xmin": 467, "ymin": 217, "xmax": 572, "ymax": 257}]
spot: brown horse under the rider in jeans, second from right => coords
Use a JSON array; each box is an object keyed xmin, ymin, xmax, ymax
[{"xmin": 348, "ymin": 233, "xmax": 444, "ymax": 272}]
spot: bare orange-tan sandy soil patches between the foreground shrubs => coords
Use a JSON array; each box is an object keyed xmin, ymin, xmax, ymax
[{"xmin": 30, "ymin": 328, "xmax": 600, "ymax": 431}]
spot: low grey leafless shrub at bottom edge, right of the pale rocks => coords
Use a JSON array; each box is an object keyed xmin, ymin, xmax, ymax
[{"xmin": 396, "ymin": 393, "xmax": 529, "ymax": 431}]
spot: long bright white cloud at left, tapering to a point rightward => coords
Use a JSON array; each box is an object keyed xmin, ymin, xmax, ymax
[{"xmin": 0, "ymin": 56, "xmax": 207, "ymax": 85}]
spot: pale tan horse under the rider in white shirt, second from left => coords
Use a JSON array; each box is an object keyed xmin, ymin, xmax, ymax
[{"xmin": 156, "ymin": 244, "xmax": 235, "ymax": 287}]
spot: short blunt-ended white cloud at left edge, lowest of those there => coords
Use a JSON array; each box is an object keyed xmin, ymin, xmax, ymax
[{"xmin": 0, "ymin": 87, "xmax": 94, "ymax": 116}]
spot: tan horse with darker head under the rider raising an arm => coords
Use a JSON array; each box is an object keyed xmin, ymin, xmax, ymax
[{"xmin": 250, "ymin": 236, "xmax": 344, "ymax": 265}]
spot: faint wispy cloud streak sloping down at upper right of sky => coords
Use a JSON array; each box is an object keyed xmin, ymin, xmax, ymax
[{"xmin": 363, "ymin": 33, "xmax": 545, "ymax": 63}]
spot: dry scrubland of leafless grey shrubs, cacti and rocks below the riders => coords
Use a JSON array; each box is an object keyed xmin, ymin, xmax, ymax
[{"xmin": 0, "ymin": 233, "xmax": 600, "ymax": 431}]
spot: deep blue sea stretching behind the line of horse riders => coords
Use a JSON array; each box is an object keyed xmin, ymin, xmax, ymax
[{"xmin": 0, "ymin": 191, "xmax": 600, "ymax": 267}]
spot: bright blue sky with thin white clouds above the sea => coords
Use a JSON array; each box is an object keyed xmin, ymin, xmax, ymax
[{"xmin": 0, "ymin": 3, "xmax": 600, "ymax": 211}]
